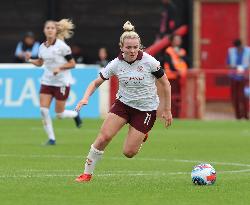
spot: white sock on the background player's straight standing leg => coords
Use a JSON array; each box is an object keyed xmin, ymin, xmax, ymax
[{"xmin": 40, "ymin": 107, "xmax": 56, "ymax": 140}]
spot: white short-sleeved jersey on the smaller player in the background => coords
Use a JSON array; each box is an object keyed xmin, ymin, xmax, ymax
[{"xmin": 38, "ymin": 39, "xmax": 72, "ymax": 87}]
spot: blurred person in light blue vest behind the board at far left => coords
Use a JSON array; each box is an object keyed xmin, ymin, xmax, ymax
[{"xmin": 15, "ymin": 31, "xmax": 40, "ymax": 63}]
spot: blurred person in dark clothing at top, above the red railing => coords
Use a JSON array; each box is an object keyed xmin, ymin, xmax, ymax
[{"xmin": 158, "ymin": 0, "xmax": 176, "ymax": 38}]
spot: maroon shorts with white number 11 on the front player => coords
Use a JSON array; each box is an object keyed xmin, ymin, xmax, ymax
[{"xmin": 110, "ymin": 100, "xmax": 156, "ymax": 134}]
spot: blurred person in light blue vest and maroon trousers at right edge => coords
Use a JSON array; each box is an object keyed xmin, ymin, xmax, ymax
[{"xmin": 227, "ymin": 39, "xmax": 250, "ymax": 119}]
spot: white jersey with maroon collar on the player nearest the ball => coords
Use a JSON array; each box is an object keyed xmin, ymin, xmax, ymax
[{"xmin": 100, "ymin": 52, "xmax": 160, "ymax": 111}]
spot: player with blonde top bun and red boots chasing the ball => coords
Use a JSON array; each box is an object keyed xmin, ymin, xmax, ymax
[{"xmin": 76, "ymin": 21, "xmax": 172, "ymax": 182}]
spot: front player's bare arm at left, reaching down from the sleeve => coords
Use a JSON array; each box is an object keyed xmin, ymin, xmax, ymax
[{"xmin": 75, "ymin": 77, "xmax": 105, "ymax": 111}]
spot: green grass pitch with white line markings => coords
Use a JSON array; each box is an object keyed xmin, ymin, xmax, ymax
[{"xmin": 0, "ymin": 119, "xmax": 250, "ymax": 205}]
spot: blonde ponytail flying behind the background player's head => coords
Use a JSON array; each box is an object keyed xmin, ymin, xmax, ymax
[{"xmin": 56, "ymin": 19, "xmax": 75, "ymax": 40}]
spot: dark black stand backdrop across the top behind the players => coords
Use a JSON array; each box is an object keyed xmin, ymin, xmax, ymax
[{"xmin": 0, "ymin": 0, "xmax": 191, "ymax": 63}]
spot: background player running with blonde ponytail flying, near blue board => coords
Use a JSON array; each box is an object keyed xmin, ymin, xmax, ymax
[{"xmin": 26, "ymin": 19, "xmax": 82, "ymax": 145}]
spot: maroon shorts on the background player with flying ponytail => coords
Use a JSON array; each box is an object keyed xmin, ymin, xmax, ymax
[{"xmin": 40, "ymin": 85, "xmax": 70, "ymax": 100}]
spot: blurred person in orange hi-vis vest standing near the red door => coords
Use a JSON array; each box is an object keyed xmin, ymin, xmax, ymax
[{"xmin": 163, "ymin": 35, "xmax": 188, "ymax": 117}]
